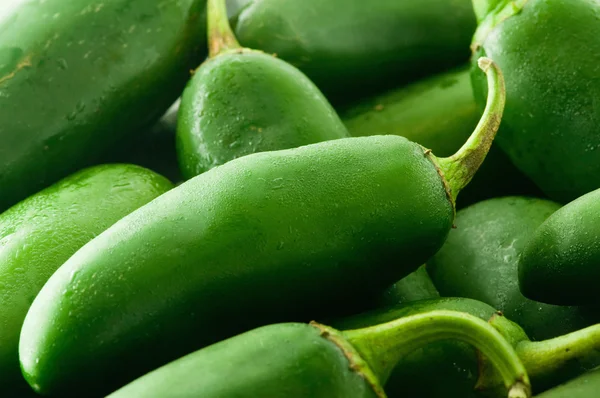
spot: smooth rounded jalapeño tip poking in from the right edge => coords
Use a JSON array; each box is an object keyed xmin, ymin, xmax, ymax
[{"xmin": 519, "ymin": 189, "xmax": 600, "ymax": 305}]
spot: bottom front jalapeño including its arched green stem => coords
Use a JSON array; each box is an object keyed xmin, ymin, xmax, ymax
[{"xmin": 108, "ymin": 311, "xmax": 530, "ymax": 398}]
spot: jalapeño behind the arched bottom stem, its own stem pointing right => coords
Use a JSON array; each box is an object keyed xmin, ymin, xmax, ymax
[{"xmin": 336, "ymin": 297, "xmax": 600, "ymax": 398}]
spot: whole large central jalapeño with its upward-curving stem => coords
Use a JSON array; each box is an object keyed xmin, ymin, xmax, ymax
[{"xmin": 19, "ymin": 58, "xmax": 504, "ymax": 396}]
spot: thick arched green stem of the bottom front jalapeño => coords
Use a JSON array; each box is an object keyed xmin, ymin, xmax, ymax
[{"xmin": 342, "ymin": 311, "xmax": 531, "ymax": 398}]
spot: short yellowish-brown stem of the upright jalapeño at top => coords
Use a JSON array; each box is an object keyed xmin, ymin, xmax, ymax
[{"xmin": 207, "ymin": 0, "xmax": 241, "ymax": 58}]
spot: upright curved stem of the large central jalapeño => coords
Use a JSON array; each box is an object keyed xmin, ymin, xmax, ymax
[{"xmin": 436, "ymin": 57, "xmax": 506, "ymax": 201}]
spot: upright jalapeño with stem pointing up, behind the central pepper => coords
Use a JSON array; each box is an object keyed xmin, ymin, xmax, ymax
[{"xmin": 177, "ymin": 0, "xmax": 349, "ymax": 178}]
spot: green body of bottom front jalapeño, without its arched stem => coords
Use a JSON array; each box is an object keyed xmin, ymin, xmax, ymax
[{"xmin": 109, "ymin": 323, "xmax": 378, "ymax": 398}]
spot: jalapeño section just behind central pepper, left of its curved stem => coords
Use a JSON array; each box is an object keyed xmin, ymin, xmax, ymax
[{"xmin": 340, "ymin": 65, "xmax": 481, "ymax": 156}]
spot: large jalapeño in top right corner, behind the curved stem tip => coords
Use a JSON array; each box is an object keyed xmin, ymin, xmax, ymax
[{"xmin": 472, "ymin": 0, "xmax": 600, "ymax": 203}]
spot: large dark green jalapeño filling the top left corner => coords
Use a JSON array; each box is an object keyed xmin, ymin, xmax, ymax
[{"xmin": 0, "ymin": 0, "xmax": 206, "ymax": 211}]
